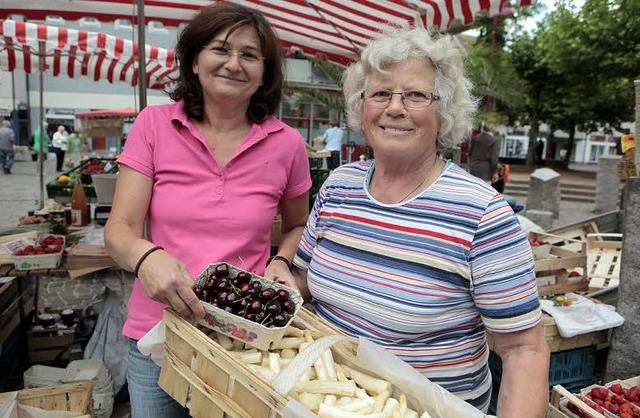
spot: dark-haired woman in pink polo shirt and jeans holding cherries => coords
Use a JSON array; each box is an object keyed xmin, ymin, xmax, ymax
[{"xmin": 105, "ymin": 2, "xmax": 311, "ymax": 418}]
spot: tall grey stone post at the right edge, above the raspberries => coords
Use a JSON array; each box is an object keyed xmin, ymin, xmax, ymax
[{"xmin": 604, "ymin": 177, "xmax": 640, "ymax": 382}]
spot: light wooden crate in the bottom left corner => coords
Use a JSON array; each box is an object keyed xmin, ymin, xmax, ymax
[{"xmin": 0, "ymin": 381, "xmax": 93, "ymax": 418}]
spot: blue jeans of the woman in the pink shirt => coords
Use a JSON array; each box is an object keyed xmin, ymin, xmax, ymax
[{"xmin": 127, "ymin": 338, "xmax": 189, "ymax": 418}]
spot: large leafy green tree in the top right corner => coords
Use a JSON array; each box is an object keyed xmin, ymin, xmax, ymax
[{"xmin": 539, "ymin": 0, "xmax": 640, "ymax": 168}]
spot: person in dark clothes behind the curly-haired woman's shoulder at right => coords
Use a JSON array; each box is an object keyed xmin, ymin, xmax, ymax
[{"xmin": 467, "ymin": 128, "xmax": 500, "ymax": 184}]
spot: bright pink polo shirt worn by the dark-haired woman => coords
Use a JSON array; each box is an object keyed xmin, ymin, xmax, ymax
[{"xmin": 118, "ymin": 102, "xmax": 311, "ymax": 339}]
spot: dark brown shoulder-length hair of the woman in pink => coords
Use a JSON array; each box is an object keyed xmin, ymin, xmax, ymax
[{"xmin": 169, "ymin": 2, "xmax": 284, "ymax": 123}]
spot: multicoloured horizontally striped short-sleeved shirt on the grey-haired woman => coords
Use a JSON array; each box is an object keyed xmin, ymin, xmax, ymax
[{"xmin": 294, "ymin": 161, "xmax": 541, "ymax": 410}]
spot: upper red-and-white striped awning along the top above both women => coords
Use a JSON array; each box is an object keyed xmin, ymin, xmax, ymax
[{"xmin": 0, "ymin": 0, "xmax": 535, "ymax": 64}]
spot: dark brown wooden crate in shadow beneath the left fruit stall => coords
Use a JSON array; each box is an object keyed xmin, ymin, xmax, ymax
[{"xmin": 27, "ymin": 325, "xmax": 76, "ymax": 364}]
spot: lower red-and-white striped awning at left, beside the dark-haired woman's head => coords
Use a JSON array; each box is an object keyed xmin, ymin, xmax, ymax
[{"xmin": 0, "ymin": 20, "xmax": 178, "ymax": 89}]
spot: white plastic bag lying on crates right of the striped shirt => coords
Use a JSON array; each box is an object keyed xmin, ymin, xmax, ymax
[{"xmin": 540, "ymin": 293, "xmax": 624, "ymax": 338}]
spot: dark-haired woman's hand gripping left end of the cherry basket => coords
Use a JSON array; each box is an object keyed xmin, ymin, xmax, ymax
[{"xmin": 138, "ymin": 251, "xmax": 204, "ymax": 318}]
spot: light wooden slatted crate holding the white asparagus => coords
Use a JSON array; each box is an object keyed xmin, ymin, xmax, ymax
[{"xmin": 158, "ymin": 308, "xmax": 470, "ymax": 418}]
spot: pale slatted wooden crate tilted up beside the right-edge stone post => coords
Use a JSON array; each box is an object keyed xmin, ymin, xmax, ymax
[{"xmin": 586, "ymin": 234, "xmax": 622, "ymax": 292}]
